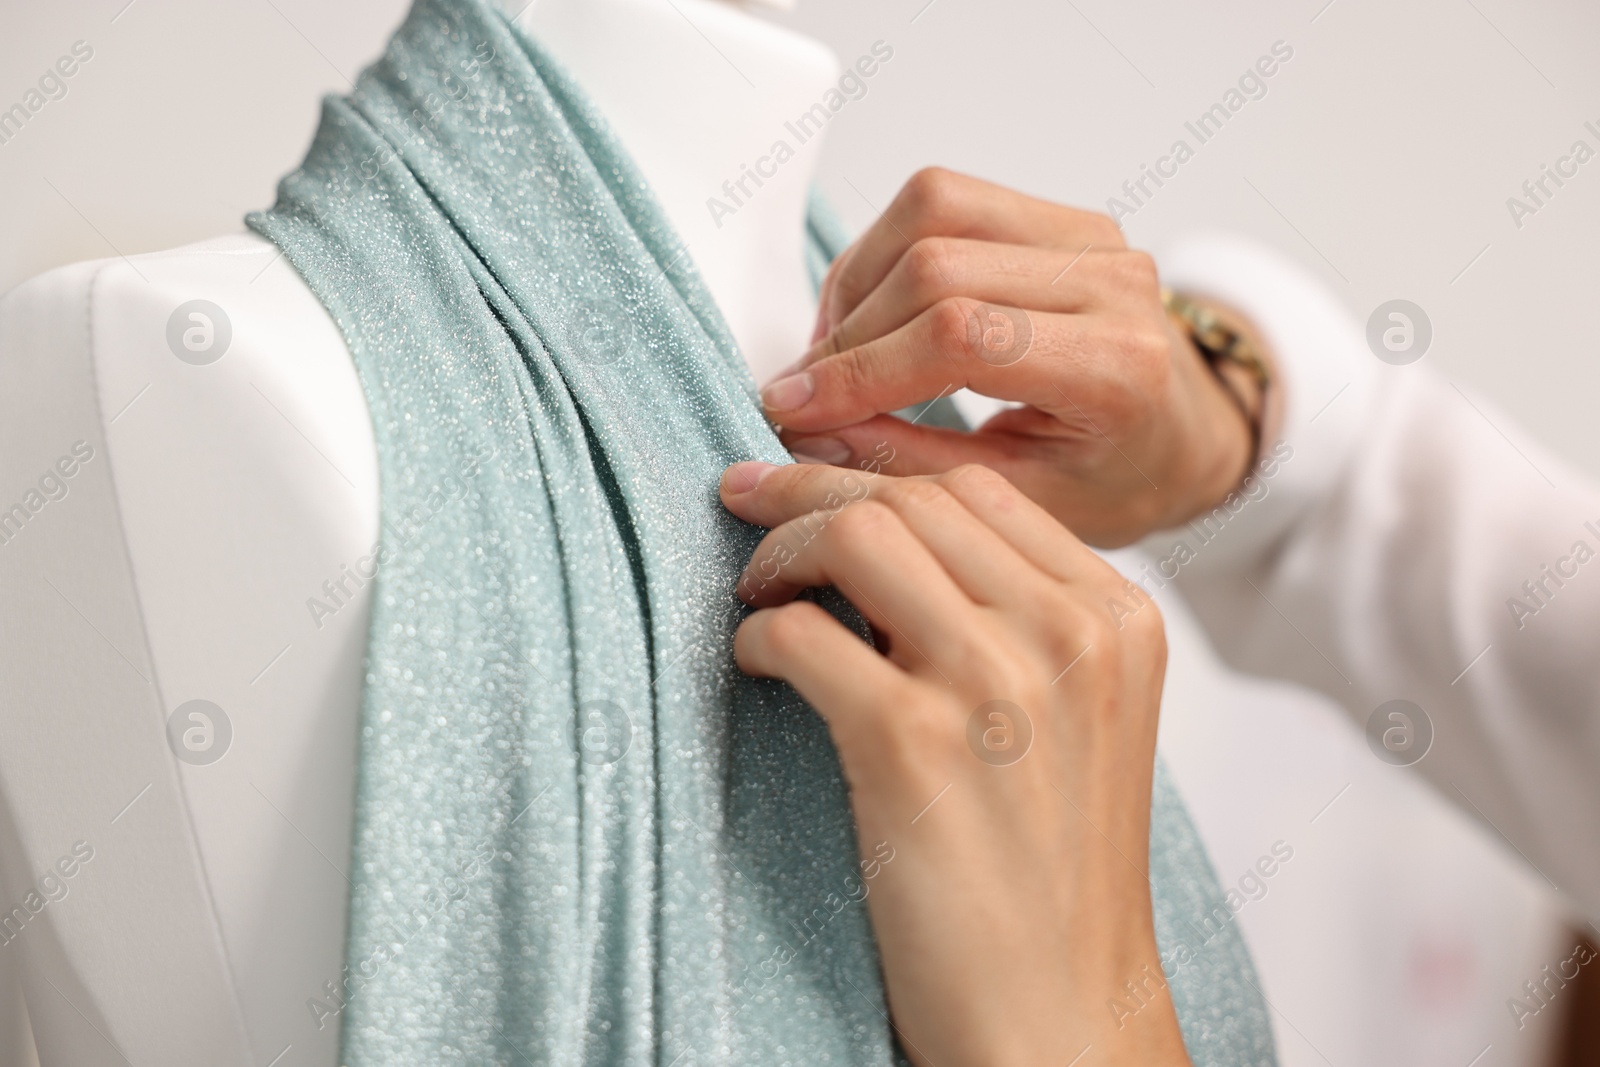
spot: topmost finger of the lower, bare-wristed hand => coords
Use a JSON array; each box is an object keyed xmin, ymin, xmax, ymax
[{"xmin": 723, "ymin": 464, "xmax": 1043, "ymax": 605}]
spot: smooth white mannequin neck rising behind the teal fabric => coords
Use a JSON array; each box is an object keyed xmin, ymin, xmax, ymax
[{"xmin": 518, "ymin": 0, "xmax": 838, "ymax": 381}]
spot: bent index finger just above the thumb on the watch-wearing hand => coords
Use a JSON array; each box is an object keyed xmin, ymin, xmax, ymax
[{"xmin": 762, "ymin": 298, "xmax": 1171, "ymax": 430}]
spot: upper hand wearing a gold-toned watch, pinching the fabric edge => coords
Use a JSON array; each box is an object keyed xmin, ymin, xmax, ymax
[{"xmin": 762, "ymin": 170, "xmax": 1253, "ymax": 545}]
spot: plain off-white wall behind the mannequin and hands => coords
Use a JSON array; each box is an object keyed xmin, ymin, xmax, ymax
[{"xmin": 0, "ymin": 0, "xmax": 1600, "ymax": 1067}]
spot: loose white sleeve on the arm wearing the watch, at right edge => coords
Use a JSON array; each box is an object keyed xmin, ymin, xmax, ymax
[{"xmin": 1146, "ymin": 231, "xmax": 1600, "ymax": 917}]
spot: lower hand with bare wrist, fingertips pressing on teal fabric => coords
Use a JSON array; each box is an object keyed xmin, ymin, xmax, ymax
[{"xmin": 722, "ymin": 462, "xmax": 1189, "ymax": 1067}]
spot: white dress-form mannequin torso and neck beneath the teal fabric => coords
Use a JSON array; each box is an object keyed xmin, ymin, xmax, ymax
[{"xmin": 0, "ymin": 0, "xmax": 838, "ymax": 1067}]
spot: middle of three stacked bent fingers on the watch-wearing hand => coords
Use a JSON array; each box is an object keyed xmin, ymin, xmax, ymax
[{"xmin": 797, "ymin": 237, "xmax": 1160, "ymax": 375}]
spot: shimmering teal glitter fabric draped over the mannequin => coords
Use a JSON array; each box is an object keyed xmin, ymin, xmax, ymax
[{"xmin": 248, "ymin": 0, "xmax": 1272, "ymax": 1067}]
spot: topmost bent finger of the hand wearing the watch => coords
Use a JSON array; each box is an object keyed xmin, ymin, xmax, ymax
[{"xmin": 822, "ymin": 168, "xmax": 1125, "ymax": 337}]
